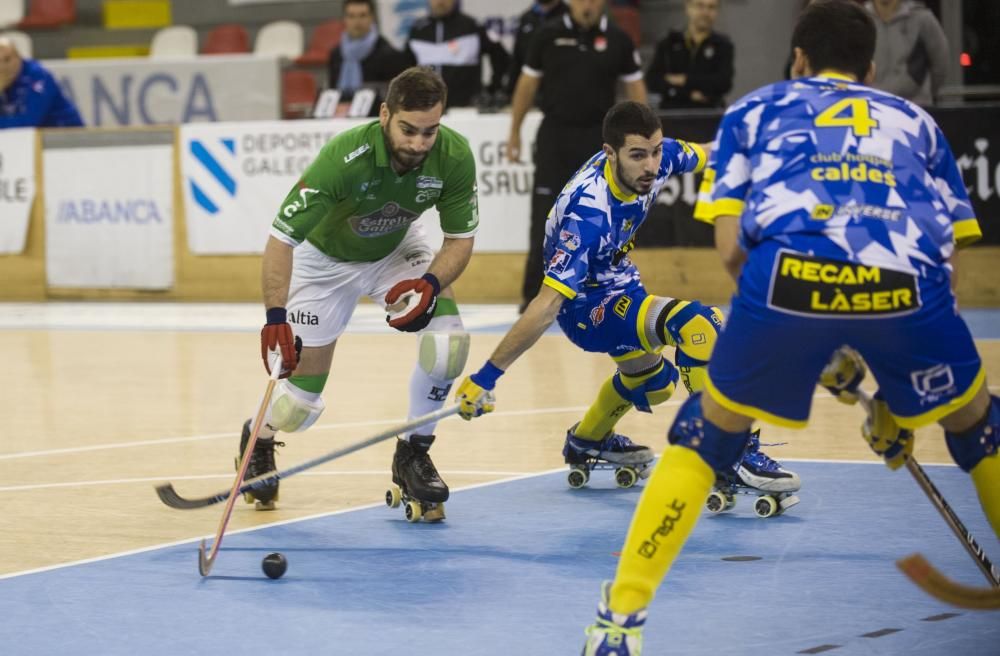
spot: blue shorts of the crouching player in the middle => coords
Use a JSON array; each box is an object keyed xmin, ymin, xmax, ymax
[{"xmin": 556, "ymin": 283, "xmax": 656, "ymax": 358}]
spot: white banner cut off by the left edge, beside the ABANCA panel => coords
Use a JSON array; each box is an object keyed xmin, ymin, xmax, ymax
[{"xmin": 0, "ymin": 129, "xmax": 35, "ymax": 255}]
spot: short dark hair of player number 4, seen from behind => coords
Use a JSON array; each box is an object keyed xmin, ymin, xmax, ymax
[{"xmin": 792, "ymin": 0, "xmax": 875, "ymax": 80}]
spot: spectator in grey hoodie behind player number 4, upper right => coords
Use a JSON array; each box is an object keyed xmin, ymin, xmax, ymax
[{"xmin": 865, "ymin": 0, "xmax": 948, "ymax": 105}]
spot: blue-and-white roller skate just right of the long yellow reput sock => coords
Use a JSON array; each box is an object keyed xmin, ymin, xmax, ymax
[{"xmin": 705, "ymin": 430, "xmax": 802, "ymax": 518}]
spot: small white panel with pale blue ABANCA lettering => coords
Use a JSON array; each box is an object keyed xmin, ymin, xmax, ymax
[{"xmin": 44, "ymin": 145, "xmax": 174, "ymax": 289}]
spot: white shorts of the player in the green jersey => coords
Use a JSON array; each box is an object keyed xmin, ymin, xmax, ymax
[{"xmin": 287, "ymin": 224, "xmax": 434, "ymax": 346}]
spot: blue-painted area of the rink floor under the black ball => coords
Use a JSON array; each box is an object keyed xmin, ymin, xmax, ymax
[{"xmin": 0, "ymin": 462, "xmax": 1000, "ymax": 656}]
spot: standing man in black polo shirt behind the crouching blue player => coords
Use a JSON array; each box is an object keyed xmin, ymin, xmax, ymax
[{"xmin": 507, "ymin": 0, "xmax": 646, "ymax": 312}]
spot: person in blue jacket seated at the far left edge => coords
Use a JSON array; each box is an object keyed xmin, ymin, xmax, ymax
[{"xmin": 0, "ymin": 36, "xmax": 83, "ymax": 128}]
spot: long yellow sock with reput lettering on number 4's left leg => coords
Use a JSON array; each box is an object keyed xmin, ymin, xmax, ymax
[{"xmin": 609, "ymin": 446, "xmax": 715, "ymax": 614}]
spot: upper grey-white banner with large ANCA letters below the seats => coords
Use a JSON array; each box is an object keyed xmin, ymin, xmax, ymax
[{"xmin": 44, "ymin": 55, "xmax": 281, "ymax": 127}]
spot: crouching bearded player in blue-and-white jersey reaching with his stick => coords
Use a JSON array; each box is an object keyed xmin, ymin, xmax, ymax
[{"xmin": 456, "ymin": 102, "xmax": 799, "ymax": 493}]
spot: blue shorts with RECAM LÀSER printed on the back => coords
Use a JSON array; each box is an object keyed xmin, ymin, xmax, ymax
[{"xmin": 706, "ymin": 244, "xmax": 985, "ymax": 428}]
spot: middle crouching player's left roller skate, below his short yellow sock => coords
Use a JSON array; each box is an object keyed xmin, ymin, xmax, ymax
[{"xmin": 563, "ymin": 425, "xmax": 653, "ymax": 489}]
